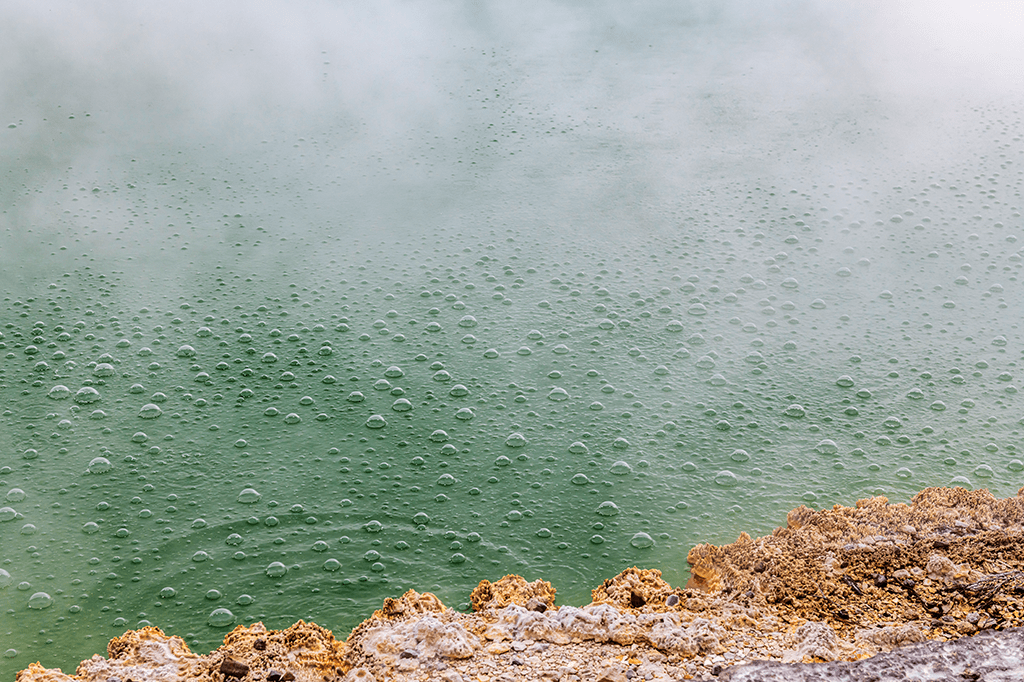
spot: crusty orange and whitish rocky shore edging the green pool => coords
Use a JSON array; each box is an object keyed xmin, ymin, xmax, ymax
[{"xmin": 17, "ymin": 488, "xmax": 1024, "ymax": 682}]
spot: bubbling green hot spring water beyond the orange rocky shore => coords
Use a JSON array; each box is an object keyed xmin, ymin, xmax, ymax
[{"xmin": 0, "ymin": 0, "xmax": 1024, "ymax": 679}]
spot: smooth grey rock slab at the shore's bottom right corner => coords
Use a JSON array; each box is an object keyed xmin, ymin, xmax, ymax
[{"xmin": 719, "ymin": 628, "xmax": 1024, "ymax": 682}]
